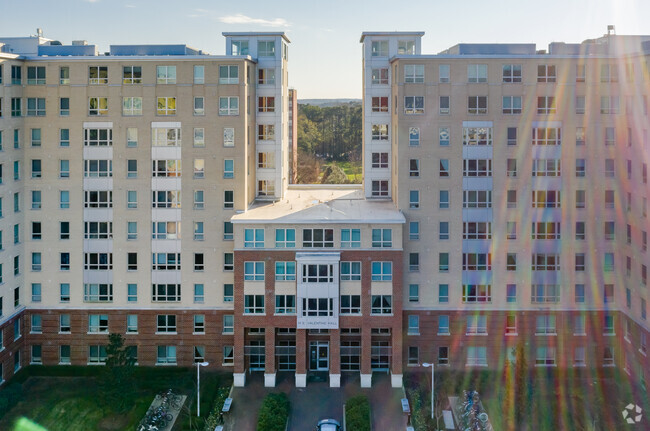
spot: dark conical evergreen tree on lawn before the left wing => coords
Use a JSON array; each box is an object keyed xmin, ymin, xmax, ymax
[{"xmin": 102, "ymin": 333, "xmax": 135, "ymax": 412}]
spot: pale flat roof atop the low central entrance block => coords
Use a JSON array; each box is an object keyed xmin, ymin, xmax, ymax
[{"xmin": 231, "ymin": 186, "xmax": 406, "ymax": 224}]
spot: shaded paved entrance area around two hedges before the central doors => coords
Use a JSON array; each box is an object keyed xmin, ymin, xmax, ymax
[{"xmin": 224, "ymin": 373, "xmax": 406, "ymax": 431}]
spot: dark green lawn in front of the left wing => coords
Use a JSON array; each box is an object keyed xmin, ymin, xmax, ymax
[{"xmin": 0, "ymin": 367, "xmax": 232, "ymax": 431}]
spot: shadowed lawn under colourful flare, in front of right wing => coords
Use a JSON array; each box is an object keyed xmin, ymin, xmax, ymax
[{"xmin": 404, "ymin": 368, "xmax": 650, "ymax": 431}]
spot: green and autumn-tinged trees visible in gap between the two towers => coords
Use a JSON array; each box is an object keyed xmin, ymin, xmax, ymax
[{"xmin": 298, "ymin": 102, "xmax": 361, "ymax": 162}]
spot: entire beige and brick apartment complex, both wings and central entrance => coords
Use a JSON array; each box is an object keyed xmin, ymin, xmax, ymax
[{"xmin": 0, "ymin": 27, "xmax": 650, "ymax": 387}]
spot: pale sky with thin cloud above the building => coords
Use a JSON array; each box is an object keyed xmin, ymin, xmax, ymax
[{"xmin": 0, "ymin": 0, "xmax": 650, "ymax": 99}]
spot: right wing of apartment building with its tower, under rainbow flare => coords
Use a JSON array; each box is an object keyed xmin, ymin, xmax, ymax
[{"xmin": 361, "ymin": 32, "xmax": 650, "ymax": 382}]
